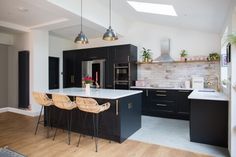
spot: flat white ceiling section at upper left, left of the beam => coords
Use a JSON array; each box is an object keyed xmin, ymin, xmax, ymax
[{"xmin": 0, "ymin": 0, "xmax": 105, "ymax": 40}]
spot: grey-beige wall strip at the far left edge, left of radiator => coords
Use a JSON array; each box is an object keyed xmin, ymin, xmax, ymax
[{"xmin": 0, "ymin": 44, "xmax": 8, "ymax": 108}]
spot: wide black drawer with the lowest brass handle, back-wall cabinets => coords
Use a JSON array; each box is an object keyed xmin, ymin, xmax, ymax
[{"xmin": 150, "ymin": 100, "xmax": 176, "ymax": 113}]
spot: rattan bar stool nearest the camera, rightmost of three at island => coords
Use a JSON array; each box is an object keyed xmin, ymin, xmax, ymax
[{"xmin": 76, "ymin": 97, "xmax": 110, "ymax": 152}]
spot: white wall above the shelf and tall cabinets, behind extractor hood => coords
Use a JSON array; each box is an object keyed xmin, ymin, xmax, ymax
[{"xmin": 78, "ymin": 22, "xmax": 221, "ymax": 60}]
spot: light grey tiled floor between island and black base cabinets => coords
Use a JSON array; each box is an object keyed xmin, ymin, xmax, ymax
[{"xmin": 129, "ymin": 116, "xmax": 228, "ymax": 157}]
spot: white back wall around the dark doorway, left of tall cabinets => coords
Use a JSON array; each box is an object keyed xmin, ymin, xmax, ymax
[{"xmin": 49, "ymin": 35, "xmax": 77, "ymax": 88}]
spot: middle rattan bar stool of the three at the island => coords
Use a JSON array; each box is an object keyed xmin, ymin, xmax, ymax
[{"xmin": 52, "ymin": 94, "xmax": 77, "ymax": 145}]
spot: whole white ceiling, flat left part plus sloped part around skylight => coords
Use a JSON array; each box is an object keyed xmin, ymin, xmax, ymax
[{"xmin": 0, "ymin": 0, "xmax": 231, "ymax": 40}]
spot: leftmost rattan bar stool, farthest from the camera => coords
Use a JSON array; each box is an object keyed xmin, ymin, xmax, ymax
[{"xmin": 32, "ymin": 92, "xmax": 53, "ymax": 137}]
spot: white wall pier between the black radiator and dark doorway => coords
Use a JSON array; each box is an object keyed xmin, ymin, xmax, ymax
[{"xmin": 30, "ymin": 30, "xmax": 49, "ymax": 112}]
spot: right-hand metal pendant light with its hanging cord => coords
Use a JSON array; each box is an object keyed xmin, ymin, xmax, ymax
[{"xmin": 103, "ymin": 0, "xmax": 118, "ymax": 41}]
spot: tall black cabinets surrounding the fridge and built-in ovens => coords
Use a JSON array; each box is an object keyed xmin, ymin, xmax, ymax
[{"xmin": 63, "ymin": 44, "xmax": 137, "ymax": 89}]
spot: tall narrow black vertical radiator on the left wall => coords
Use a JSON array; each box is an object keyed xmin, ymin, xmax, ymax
[{"xmin": 18, "ymin": 51, "xmax": 30, "ymax": 109}]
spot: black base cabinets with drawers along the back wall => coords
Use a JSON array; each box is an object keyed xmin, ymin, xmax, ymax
[{"xmin": 135, "ymin": 89, "xmax": 192, "ymax": 120}]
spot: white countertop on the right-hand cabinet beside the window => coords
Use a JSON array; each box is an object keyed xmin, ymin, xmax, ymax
[{"xmin": 188, "ymin": 89, "xmax": 228, "ymax": 101}]
